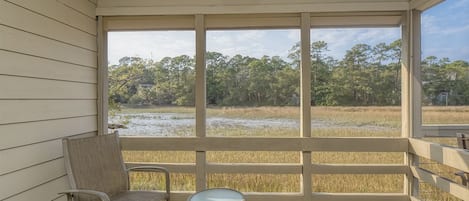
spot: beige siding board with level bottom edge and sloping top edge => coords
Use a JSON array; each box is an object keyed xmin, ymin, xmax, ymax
[{"xmin": 0, "ymin": 75, "xmax": 97, "ymax": 99}]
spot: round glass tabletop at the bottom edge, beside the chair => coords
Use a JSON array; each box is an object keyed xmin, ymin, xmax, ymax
[{"xmin": 187, "ymin": 188, "xmax": 245, "ymax": 201}]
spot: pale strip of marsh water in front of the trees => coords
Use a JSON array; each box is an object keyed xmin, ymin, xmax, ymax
[{"xmin": 109, "ymin": 113, "xmax": 396, "ymax": 136}]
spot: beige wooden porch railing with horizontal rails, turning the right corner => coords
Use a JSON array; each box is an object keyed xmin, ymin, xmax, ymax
[{"xmin": 121, "ymin": 137, "xmax": 469, "ymax": 201}]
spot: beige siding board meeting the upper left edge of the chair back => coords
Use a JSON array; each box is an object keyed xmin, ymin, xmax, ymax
[{"xmin": 0, "ymin": 140, "xmax": 63, "ymax": 175}]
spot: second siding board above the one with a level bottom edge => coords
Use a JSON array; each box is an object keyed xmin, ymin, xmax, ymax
[{"xmin": 0, "ymin": 25, "xmax": 97, "ymax": 67}]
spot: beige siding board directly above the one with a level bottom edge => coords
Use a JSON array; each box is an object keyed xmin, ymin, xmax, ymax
[{"xmin": 0, "ymin": 50, "xmax": 97, "ymax": 83}]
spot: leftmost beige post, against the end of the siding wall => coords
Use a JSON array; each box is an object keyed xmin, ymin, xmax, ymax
[{"xmin": 97, "ymin": 16, "xmax": 109, "ymax": 135}]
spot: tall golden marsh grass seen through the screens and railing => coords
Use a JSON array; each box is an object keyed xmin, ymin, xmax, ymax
[{"xmin": 119, "ymin": 107, "xmax": 469, "ymax": 200}]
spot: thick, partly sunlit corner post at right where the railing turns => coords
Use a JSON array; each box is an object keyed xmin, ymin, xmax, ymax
[{"xmin": 401, "ymin": 10, "xmax": 422, "ymax": 197}]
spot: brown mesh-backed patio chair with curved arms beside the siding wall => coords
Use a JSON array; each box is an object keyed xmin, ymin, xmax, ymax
[{"xmin": 60, "ymin": 134, "xmax": 170, "ymax": 201}]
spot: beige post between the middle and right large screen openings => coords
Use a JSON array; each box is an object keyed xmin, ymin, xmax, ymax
[{"xmin": 300, "ymin": 13, "xmax": 312, "ymax": 201}]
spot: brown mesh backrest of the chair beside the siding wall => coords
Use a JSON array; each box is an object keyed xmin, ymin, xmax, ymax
[{"xmin": 63, "ymin": 134, "xmax": 129, "ymax": 201}]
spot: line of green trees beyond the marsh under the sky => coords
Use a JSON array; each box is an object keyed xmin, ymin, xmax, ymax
[{"xmin": 108, "ymin": 40, "xmax": 469, "ymax": 106}]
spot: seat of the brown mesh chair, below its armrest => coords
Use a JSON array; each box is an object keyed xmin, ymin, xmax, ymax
[{"xmin": 111, "ymin": 191, "xmax": 166, "ymax": 201}]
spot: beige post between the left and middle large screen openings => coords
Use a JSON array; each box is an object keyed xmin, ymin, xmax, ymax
[{"xmin": 195, "ymin": 15, "xmax": 207, "ymax": 191}]
